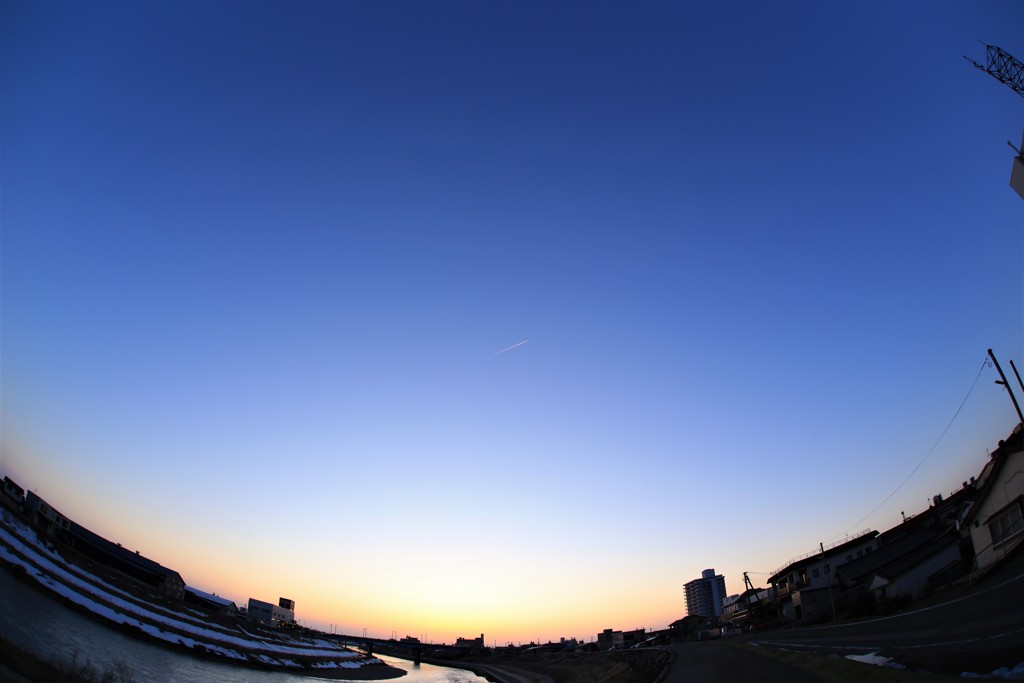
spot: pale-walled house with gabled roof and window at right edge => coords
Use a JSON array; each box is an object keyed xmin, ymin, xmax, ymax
[{"xmin": 964, "ymin": 425, "xmax": 1024, "ymax": 574}]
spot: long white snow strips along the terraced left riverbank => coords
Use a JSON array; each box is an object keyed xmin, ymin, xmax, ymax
[{"xmin": 0, "ymin": 512, "xmax": 383, "ymax": 669}]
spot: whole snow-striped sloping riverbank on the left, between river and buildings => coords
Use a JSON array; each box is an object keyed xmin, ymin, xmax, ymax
[{"xmin": 0, "ymin": 511, "xmax": 406, "ymax": 680}]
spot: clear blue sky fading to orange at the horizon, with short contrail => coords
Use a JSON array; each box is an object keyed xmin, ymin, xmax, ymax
[{"xmin": 0, "ymin": 0, "xmax": 1024, "ymax": 644}]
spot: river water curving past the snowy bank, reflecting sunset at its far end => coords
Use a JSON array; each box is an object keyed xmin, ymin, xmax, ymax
[{"xmin": 0, "ymin": 568, "xmax": 485, "ymax": 683}]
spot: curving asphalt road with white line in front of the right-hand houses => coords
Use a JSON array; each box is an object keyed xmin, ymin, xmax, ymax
[{"xmin": 744, "ymin": 563, "xmax": 1024, "ymax": 673}]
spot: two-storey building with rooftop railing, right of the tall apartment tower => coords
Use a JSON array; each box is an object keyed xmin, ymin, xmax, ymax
[{"xmin": 768, "ymin": 529, "xmax": 879, "ymax": 622}]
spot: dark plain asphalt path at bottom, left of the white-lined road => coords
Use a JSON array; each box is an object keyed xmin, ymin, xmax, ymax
[{"xmin": 660, "ymin": 642, "xmax": 820, "ymax": 683}]
